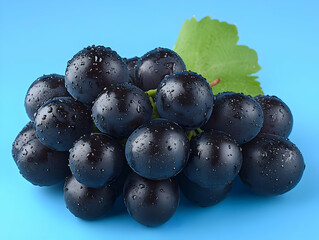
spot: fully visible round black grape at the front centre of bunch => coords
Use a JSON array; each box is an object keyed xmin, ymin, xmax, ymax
[{"xmin": 125, "ymin": 119, "xmax": 189, "ymax": 180}]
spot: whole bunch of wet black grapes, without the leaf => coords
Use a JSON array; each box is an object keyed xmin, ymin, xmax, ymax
[{"xmin": 12, "ymin": 46, "xmax": 305, "ymax": 226}]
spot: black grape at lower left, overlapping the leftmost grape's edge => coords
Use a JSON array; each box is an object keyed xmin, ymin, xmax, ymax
[{"xmin": 16, "ymin": 138, "xmax": 70, "ymax": 186}]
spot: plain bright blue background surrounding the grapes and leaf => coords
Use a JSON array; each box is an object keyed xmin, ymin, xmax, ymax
[{"xmin": 0, "ymin": 0, "xmax": 319, "ymax": 240}]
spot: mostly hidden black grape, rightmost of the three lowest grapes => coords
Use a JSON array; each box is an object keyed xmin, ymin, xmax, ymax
[{"xmin": 178, "ymin": 173, "xmax": 232, "ymax": 207}]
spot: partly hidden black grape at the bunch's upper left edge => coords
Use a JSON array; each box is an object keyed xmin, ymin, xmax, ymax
[{"xmin": 24, "ymin": 74, "xmax": 70, "ymax": 121}]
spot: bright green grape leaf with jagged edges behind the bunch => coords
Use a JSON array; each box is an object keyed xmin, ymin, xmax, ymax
[{"xmin": 174, "ymin": 17, "xmax": 263, "ymax": 96}]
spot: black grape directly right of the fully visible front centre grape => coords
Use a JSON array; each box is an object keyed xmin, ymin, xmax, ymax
[{"xmin": 183, "ymin": 130, "xmax": 243, "ymax": 188}]
